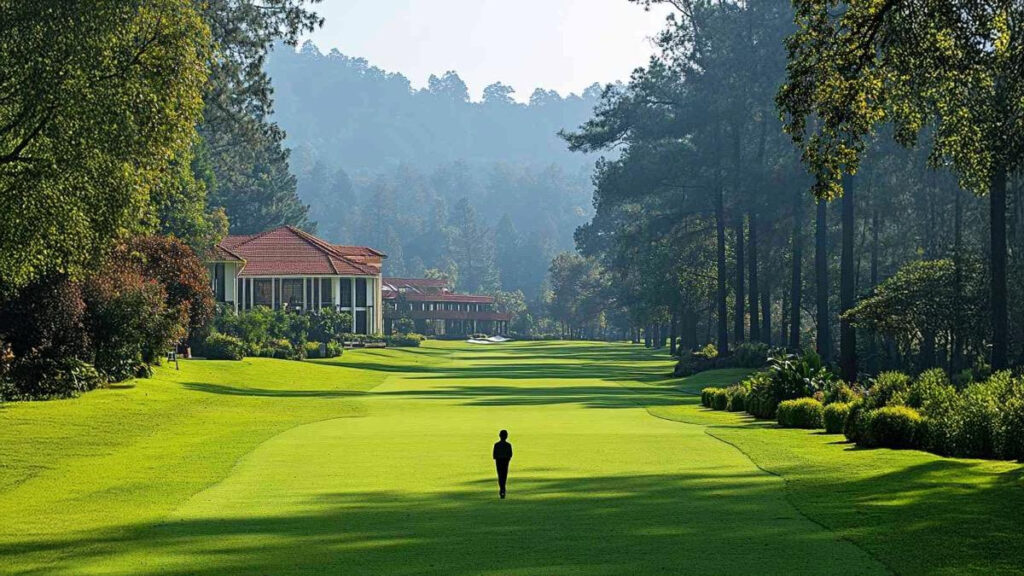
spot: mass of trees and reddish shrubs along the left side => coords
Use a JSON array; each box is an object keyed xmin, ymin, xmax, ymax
[{"xmin": 0, "ymin": 0, "xmax": 319, "ymax": 401}]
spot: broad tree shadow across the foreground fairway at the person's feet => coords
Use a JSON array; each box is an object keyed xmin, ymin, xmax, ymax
[{"xmin": 0, "ymin": 470, "xmax": 885, "ymax": 576}]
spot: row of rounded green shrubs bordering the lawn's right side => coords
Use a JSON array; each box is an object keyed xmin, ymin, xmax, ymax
[{"xmin": 700, "ymin": 363, "xmax": 1024, "ymax": 460}]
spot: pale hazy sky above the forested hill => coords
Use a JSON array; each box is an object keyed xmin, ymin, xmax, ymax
[{"xmin": 299, "ymin": 0, "xmax": 668, "ymax": 100}]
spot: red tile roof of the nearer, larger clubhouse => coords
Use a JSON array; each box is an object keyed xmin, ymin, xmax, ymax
[{"xmin": 218, "ymin": 227, "xmax": 380, "ymax": 276}]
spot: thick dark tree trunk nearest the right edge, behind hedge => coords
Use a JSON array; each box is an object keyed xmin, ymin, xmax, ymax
[{"xmin": 988, "ymin": 166, "xmax": 1009, "ymax": 370}]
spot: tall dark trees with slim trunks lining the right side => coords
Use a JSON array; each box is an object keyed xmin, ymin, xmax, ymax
[{"xmin": 552, "ymin": 0, "xmax": 1024, "ymax": 380}]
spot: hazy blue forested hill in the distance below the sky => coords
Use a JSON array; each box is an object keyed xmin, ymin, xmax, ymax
[{"xmin": 266, "ymin": 43, "xmax": 601, "ymax": 297}]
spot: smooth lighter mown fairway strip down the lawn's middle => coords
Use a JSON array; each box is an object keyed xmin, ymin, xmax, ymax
[{"xmin": 6, "ymin": 343, "xmax": 884, "ymax": 574}]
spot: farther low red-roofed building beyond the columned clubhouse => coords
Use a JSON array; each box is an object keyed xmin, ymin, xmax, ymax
[{"xmin": 383, "ymin": 278, "xmax": 511, "ymax": 336}]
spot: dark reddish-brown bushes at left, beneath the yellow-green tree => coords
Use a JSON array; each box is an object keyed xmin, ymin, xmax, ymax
[{"xmin": 0, "ymin": 237, "xmax": 213, "ymax": 400}]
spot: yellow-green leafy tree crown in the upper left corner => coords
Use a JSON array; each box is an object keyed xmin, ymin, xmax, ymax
[{"xmin": 0, "ymin": 0, "xmax": 209, "ymax": 296}]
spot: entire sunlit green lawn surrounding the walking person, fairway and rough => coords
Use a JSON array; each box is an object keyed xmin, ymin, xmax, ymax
[{"xmin": 0, "ymin": 342, "xmax": 1024, "ymax": 575}]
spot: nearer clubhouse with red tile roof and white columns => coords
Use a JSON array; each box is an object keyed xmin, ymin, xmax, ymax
[{"xmin": 207, "ymin": 225, "xmax": 387, "ymax": 334}]
